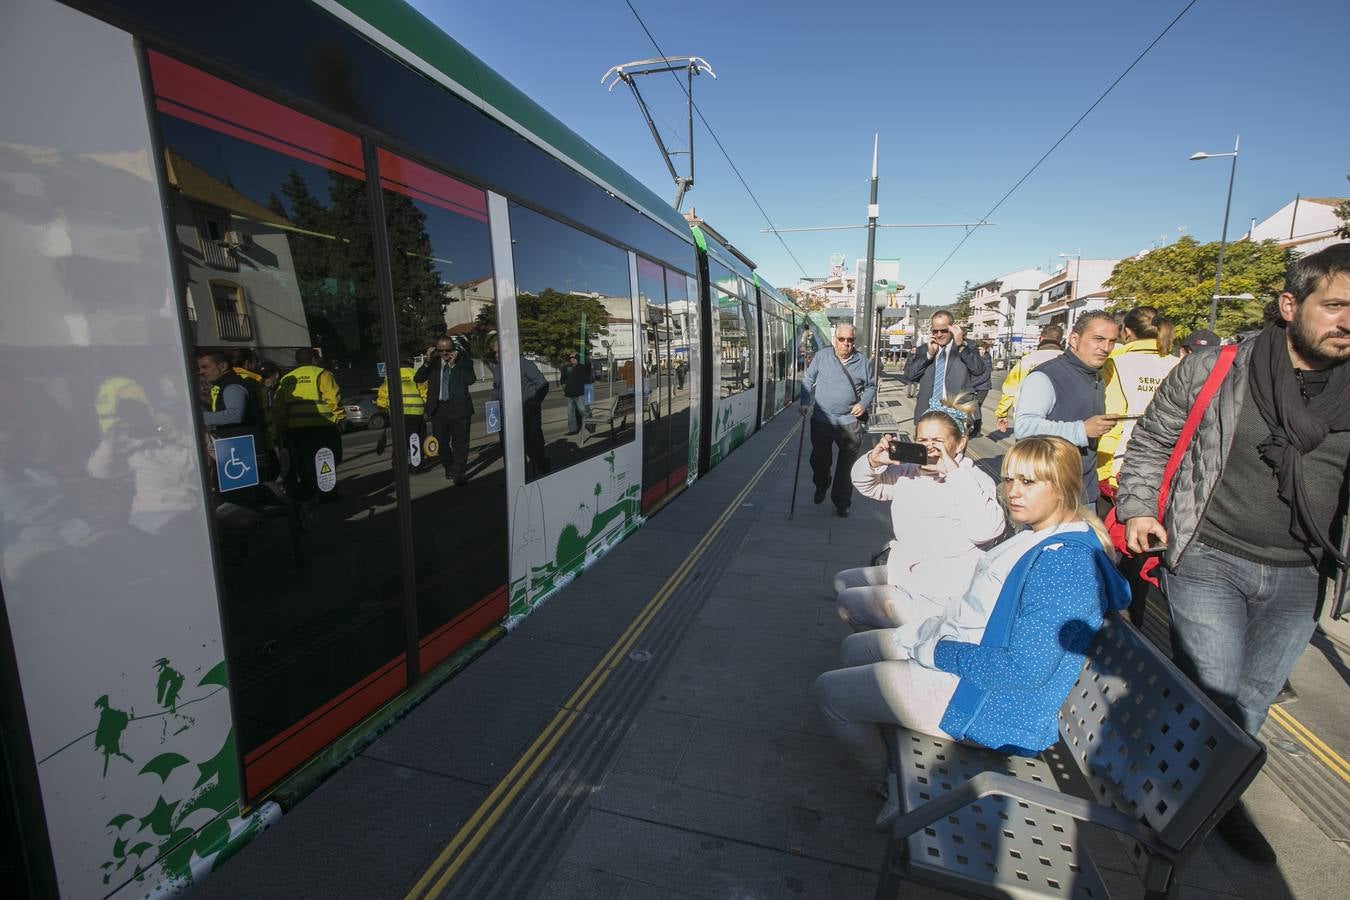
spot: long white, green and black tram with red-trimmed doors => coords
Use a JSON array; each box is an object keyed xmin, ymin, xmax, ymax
[{"xmin": 0, "ymin": 0, "xmax": 813, "ymax": 897}]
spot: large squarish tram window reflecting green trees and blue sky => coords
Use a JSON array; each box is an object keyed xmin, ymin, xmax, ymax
[{"xmin": 510, "ymin": 204, "xmax": 641, "ymax": 480}]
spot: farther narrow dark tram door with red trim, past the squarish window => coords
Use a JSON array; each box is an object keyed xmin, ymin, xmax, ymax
[{"xmin": 637, "ymin": 258, "xmax": 690, "ymax": 511}]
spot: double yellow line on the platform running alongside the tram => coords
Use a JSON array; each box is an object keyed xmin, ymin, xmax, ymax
[{"xmin": 406, "ymin": 429, "xmax": 797, "ymax": 900}]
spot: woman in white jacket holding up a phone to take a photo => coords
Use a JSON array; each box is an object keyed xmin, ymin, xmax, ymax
[{"xmin": 834, "ymin": 405, "xmax": 1007, "ymax": 631}]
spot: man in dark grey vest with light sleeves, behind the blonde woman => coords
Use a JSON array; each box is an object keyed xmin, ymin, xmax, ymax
[{"xmin": 1013, "ymin": 312, "xmax": 1121, "ymax": 509}]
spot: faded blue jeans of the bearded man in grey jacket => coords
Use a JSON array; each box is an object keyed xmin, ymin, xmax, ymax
[{"xmin": 1164, "ymin": 541, "xmax": 1318, "ymax": 737}]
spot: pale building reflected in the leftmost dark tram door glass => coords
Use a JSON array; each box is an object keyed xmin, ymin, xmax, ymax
[{"xmin": 165, "ymin": 150, "xmax": 312, "ymax": 362}]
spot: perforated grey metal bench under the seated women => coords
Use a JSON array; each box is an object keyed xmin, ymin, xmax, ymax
[{"xmin": 876, "ymin": 614, "xmax": 1265, "ymax": 899}]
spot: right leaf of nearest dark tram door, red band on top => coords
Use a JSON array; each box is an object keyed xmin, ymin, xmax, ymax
[{"xmin": 379, "ymin": 150, "xmax": 508, "ymax": 672}]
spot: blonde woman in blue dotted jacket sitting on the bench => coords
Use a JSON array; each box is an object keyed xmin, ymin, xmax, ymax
[{"xmin": 814, "ymin": 436, "xmax": 1130, "ymax": 781}]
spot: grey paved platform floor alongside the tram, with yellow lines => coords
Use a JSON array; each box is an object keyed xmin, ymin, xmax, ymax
[{"xmin": 198, "ymin": 367, "xmax": 1350, "ymax": 900}]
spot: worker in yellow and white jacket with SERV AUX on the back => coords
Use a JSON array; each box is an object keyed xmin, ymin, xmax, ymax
[{"xmin": 1096, "ymin": 306, "xmax": 1181, "ymax": 497}]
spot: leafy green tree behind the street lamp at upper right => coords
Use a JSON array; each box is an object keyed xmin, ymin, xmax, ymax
[{"xmin": 1106, "ymin": 236, "xmax": 1293, "ymax": 337}]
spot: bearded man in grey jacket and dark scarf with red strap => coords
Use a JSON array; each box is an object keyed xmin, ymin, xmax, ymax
[{"xmin": 1116, "ymin": 244, "xmax": 1350, "ymax": 862}]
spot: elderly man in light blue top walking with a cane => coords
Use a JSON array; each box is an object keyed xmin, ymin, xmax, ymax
[{"xmin": 801, "ymin": 325, "xmax": 876, "ymax": 518}]
